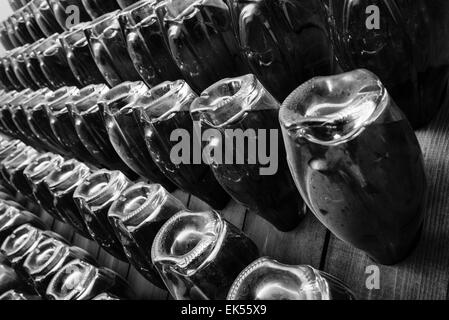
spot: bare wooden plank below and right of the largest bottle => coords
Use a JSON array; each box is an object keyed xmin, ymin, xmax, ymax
[{"xmin": 325, "ymin": 97, "xmax": 449, "ymax": 300}]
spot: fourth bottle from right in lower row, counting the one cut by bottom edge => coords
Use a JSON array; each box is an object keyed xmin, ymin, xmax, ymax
[{"xmin": 73, "ymin": 170, "xmax": 131, "ymax": 261}]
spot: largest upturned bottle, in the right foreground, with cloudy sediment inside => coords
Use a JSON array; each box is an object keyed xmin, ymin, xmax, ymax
[{"xmin": 280, "ymin": 70, "xmax": 427, "ymax": 265}]
